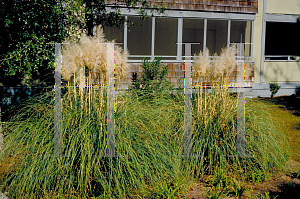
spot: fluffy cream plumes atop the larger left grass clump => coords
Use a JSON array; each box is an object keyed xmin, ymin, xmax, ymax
[{"xmin": 62, "ymin": 25, "xmax": 129, "ymax": 90}]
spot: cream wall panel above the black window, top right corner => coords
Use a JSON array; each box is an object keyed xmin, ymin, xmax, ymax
[{"xmin": 268, "ymin": 0, "xmax": 300, "ymax": 15}]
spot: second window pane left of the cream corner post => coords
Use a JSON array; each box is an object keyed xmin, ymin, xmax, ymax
[{"xmin": 206, "ymin": 20, "xmax": 228, "ymax": 55}]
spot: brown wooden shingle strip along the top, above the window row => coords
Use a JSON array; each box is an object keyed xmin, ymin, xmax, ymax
[{"xmin": 103, "ymin": 0, "xmax": 258, "ymax": 14}]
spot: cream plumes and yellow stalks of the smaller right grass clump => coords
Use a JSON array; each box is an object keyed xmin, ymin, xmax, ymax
[{"xmin": 192, "ymin": 45, "xmax": 236, "ymax": 132}]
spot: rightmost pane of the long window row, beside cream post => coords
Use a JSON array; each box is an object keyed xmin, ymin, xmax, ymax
[{"xmin": 230, "ymin": 21, "xmax": 251, "ymax": 56}]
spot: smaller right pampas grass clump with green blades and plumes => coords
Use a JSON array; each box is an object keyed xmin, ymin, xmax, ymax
[{"xmin": 188, "ymin": 46, "xmax": 289, "ymax": 182}]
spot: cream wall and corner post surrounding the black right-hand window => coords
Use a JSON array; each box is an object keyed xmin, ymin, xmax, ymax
[{"xmin": 247, "ymin": 0, "xmax": 300, "ymax": 97}]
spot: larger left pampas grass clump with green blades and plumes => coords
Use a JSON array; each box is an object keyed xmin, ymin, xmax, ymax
[{"xmin": 0, "ymin": 24, "xmax": 187, "ymax": 198}]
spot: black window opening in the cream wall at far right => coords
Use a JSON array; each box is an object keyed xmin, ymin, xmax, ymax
[{"xmin": 265, "ymin": 22, "xmax": 300, "ymax": 60}]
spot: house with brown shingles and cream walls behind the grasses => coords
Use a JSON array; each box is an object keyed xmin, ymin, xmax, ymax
[{"xmin": 92, "ymin": 0, "xmax": 300, "ymax": 97}]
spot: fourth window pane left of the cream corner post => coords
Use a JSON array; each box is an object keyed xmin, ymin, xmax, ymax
[{"xmin": 154, "ymin": 18, "xmax": 178, "ymax": 60}]
